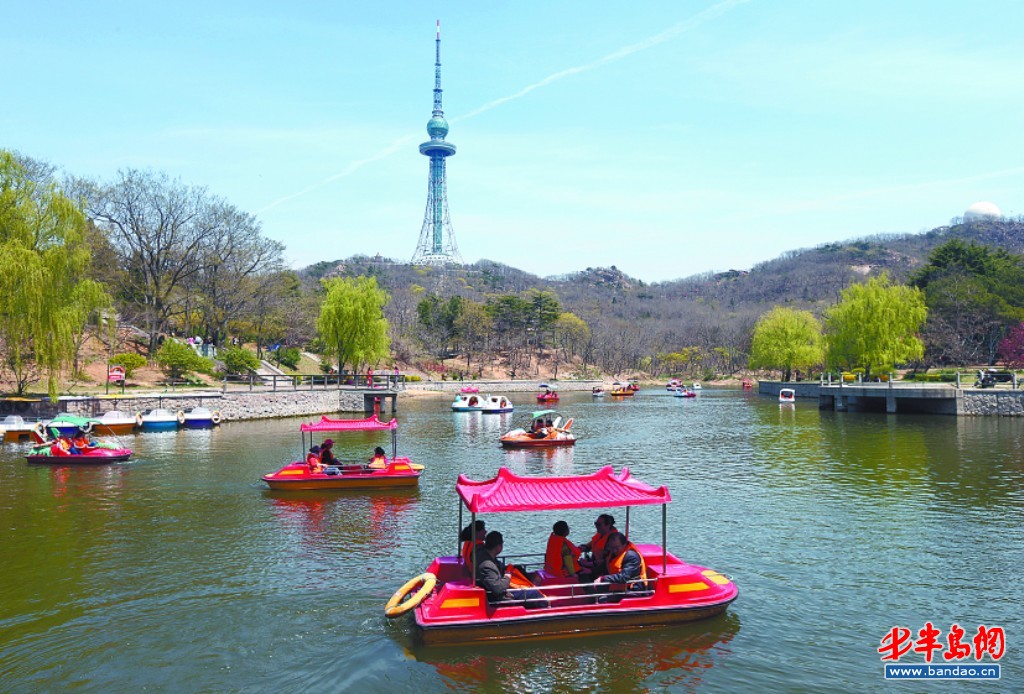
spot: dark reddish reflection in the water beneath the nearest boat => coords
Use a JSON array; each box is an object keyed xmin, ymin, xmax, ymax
[{"xmin": 410, "ymin": 613, "xmax": 739, "ymax": 691}]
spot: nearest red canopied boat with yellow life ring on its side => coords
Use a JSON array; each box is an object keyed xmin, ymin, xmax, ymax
[{"xmin": 386, "ymin": 466, "xmax": 739, "ymax": 644}]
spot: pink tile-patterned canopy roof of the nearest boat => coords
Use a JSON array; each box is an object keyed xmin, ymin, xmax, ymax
[{"xmin": 456, "ymin": 465, "xmax": 672, "ymax": 513}]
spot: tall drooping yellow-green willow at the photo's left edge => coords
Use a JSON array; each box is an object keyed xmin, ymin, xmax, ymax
[{"xmin": 0, "ymin": 150, "xmax": 110, "ymax": 399}]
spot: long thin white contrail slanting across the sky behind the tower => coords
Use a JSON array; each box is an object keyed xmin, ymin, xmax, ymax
[{"xmin": 256, "ymin": 0, "xmax": 750, "ymax": 214}]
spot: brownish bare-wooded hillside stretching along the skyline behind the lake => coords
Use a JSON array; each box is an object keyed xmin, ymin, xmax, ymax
[{"xmin": 301, "ymin": 219, "xmax": 1024, "ymax": 374}]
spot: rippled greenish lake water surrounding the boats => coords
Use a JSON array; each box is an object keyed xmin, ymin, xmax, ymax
[{"xmin": 0, "ymin": 388, "xmax": 1024, "ymax": 692}]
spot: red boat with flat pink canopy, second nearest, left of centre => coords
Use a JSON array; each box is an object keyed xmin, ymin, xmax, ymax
[{"xmin": 261, "ymin": 415, "xmax": 423, "ymax": 491}]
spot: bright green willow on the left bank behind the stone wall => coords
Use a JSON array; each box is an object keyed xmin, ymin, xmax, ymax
[{"xmin": 316, "ymin": 277, "xmax": 391, "ymax": 372}]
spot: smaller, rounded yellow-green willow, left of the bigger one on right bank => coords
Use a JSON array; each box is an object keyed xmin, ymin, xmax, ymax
[{"xmin": 750, "ymin": 306, "xmax": 824, "ymax": 381}]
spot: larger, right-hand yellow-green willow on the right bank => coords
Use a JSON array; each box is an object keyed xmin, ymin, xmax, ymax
[{"xmin": 825, "ymin": 273, "xmax": 928, "ymax": 378}]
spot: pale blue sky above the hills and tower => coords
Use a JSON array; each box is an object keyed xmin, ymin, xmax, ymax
[{"xmin": 6, "ymin": 0, "xmax": 1024, "ymax": 281}]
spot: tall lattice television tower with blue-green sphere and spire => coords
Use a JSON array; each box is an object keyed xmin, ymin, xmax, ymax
[{"xmin": 413, "ymin": 19, "xmax": 462, "ymax": 265}]
